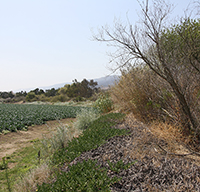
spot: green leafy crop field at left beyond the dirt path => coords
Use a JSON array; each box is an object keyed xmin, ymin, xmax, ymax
[{"xmin": 0, "ymin": 104, "xmax": 85, "ymax": 132}]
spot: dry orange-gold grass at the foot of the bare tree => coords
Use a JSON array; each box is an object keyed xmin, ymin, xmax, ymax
[{"xmin": 124, "ymin": 114, "xmax": 200, "ymax": 166}]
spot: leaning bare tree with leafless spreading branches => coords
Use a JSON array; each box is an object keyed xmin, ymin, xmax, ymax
[{"xmin": 94, "ymin": 0, "xmax": 199, "ymax": 133}]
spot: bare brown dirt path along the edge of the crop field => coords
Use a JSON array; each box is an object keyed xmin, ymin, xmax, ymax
[{"xmin": 0, "ymin": 118, "xmax": 74, "ymax": 161}]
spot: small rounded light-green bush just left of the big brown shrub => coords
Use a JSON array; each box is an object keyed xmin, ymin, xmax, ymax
[{"xmin": 94, "ymin": 93, "xmax": 113, "ymax": 113}]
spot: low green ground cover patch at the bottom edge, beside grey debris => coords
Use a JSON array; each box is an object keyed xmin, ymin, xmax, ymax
[{"xmin": 38, "ymin": 160, "xmax": 120, "ymax": 192}]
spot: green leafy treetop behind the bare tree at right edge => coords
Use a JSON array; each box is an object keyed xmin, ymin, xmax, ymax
[{"xmin": 161, "ymin": 18, "xmax": 200, "ymax": 73}]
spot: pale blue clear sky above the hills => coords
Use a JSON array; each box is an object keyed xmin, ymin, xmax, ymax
[{"xmin": 0, "ymin": 0, "xmax": 197, "ymax": 91}]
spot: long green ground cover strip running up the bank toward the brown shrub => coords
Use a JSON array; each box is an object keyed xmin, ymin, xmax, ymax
[{"xmin": 53, "ymin": 113, "xmax": 127, "ymax": 164}]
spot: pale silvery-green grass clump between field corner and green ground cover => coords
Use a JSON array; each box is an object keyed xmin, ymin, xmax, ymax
[{"xmin": 74, "ymin": 108, "xmax": 100, "ymax": 130}]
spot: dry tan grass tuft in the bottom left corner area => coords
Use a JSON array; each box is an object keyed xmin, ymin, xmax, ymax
[{"xmin": 14, "ymin": 164, "xmax": 51, "ymax": 192}]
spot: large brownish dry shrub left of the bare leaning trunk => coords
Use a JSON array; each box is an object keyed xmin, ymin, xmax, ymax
[{"xmin": 110, "ymin": 68, "xmax": 180, "ymax": 122}]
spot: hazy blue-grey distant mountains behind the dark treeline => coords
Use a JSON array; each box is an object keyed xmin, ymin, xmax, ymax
[{"xmin": 14, "ymin": 75, "xmax": 120, "ymax": 92}]
